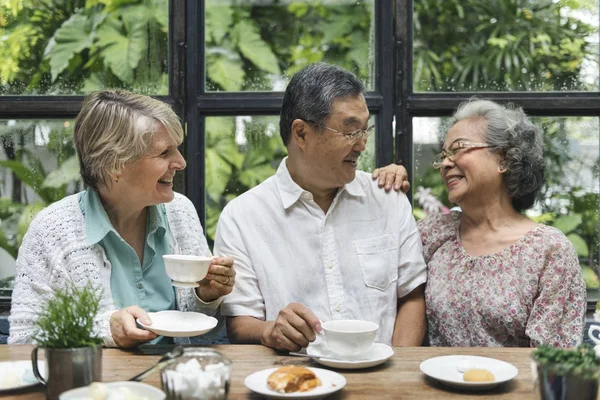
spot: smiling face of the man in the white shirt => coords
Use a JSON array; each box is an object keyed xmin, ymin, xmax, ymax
[{"xmin": 304, "ymin": 95, "xmax": 369, "ymax": 190}]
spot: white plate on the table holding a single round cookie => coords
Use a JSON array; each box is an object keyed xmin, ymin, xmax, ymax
[{"xmin": 419, "ymin": 355, "xmax": 519, "ymax": 389}]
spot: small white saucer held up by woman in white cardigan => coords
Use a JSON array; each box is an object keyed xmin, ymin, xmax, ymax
[{"xmin": 137, "ymin": 310, "xmax": 218, "ymax": 337}]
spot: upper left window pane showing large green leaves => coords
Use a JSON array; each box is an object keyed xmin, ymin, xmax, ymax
[{"xmin": 0, "ymin": 0, "xmax": 169, "ymax": 95}]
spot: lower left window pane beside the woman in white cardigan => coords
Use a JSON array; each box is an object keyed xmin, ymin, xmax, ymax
[{"xmin": 0, "ymin": 120, "xmax": 83, "ymax": 288}]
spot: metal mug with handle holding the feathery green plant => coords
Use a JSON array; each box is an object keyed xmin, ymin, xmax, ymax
[{"xmin": 31, "ymin": 346, "xmax": 102, "ymax": 400}]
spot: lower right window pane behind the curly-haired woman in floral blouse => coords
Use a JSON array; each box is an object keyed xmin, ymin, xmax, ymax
[{"xmin": 413, "ymin": 117, "xmax": 600, "ymax": 301}]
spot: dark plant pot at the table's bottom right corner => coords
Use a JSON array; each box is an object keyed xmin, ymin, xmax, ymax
[{"xmin": 532, "ymin": 362, "xmax": 598, "ymax": 400}]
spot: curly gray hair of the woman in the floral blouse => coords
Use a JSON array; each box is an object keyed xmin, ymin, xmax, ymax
[{"xmin": 452, "ymin": 99, "xmax": 544, "ymax": 212}]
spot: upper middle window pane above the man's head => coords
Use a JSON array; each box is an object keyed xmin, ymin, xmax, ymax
[{"xmin": 205, "ymin": 0, "xmax": 375, "ymax": 91}]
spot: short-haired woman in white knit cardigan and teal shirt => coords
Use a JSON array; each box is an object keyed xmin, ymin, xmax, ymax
[{"xmin": 8, "ymin": 90, "xmax": 235, "ymax": 347}]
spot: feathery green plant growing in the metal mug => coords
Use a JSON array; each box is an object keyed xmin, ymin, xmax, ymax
[{"xmin": 35, "ymin": 283, "xmax": 102, "ymax": 349}]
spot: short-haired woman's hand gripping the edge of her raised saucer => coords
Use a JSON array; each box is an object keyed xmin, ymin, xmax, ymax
[{"xmin": 110, "ymin": 306, "xmax": 157, "ymax": 348}]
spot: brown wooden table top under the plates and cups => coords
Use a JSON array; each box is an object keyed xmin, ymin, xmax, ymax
[{"xmin": 0, "ymin": 345, "xmax": 534, "ymax": 400}]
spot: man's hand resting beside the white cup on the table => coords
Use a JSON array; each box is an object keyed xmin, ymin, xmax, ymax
[{"xmin": 261, "ymin": 303, "xmax": 321, "ymax": 351}]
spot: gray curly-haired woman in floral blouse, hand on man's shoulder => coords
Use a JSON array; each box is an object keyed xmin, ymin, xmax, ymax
[{"xmin": 374, "ymin": 100, "xmax": 586, "ymax": 347}]
